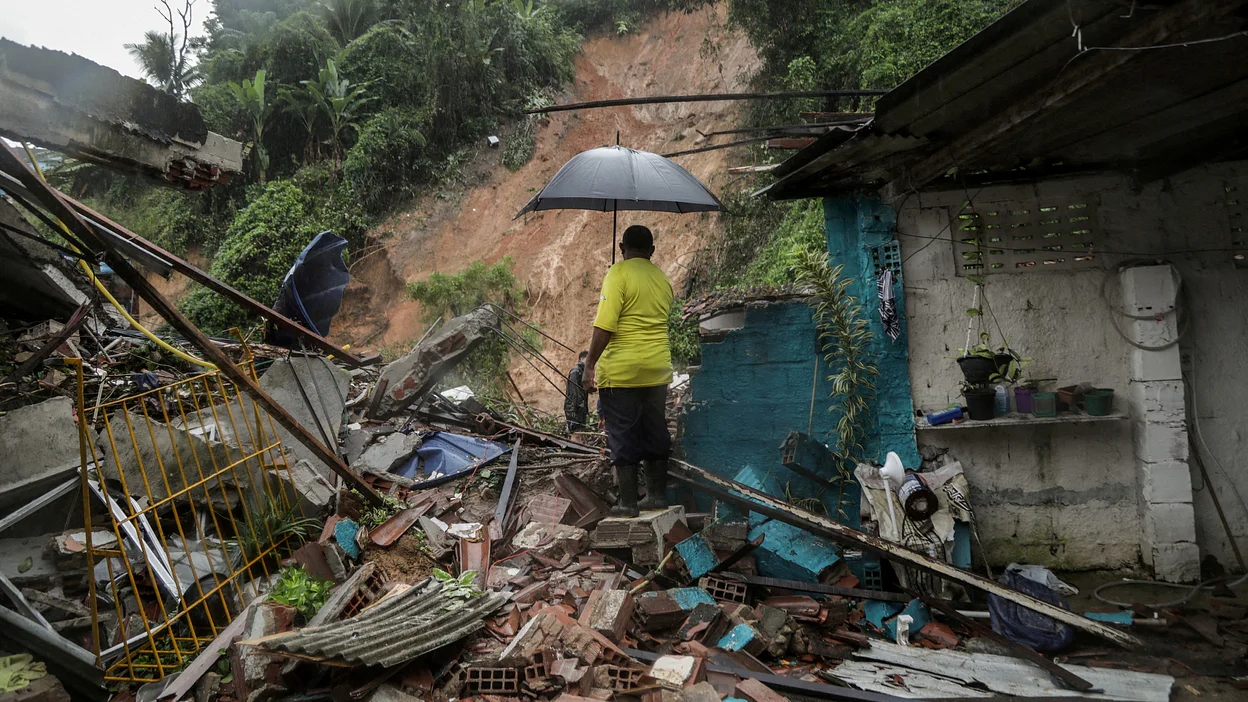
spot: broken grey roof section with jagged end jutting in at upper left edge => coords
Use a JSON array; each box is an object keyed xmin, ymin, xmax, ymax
[{"xmin": 0, "ymin": 39, "xmax": 243, "ymax": 190}]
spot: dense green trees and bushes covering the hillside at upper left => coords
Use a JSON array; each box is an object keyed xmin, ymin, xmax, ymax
[{"xmin": 73, "ymin": 0, "xmax": 698, "ymax": 334}]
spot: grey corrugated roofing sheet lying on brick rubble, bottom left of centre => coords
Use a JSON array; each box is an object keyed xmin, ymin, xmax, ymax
[{"xmin": 257, "ymin": 578, "xmax": 507, "ymax": 667}]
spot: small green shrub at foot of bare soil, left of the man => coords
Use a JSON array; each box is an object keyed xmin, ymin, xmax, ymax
[{"xmin": 407, "ymin": 256, "xmax": 540, "ymax": 397}]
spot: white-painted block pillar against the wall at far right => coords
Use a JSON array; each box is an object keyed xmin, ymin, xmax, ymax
[{"xmin": 1119, "ymin": 265, "xmax": 1201, "ymax": 582}]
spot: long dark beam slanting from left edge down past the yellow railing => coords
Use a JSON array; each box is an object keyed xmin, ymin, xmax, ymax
[{"xmin": 0, "ymin": 149, "xmax": 382, "ymax": 505}]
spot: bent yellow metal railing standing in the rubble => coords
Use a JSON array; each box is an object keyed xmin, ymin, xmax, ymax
[{"xmin": 71, "ymin": 345, "xmax": 314, "ymax": 682}]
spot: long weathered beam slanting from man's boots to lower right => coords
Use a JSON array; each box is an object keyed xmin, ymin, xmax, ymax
[{"xmin": 671, "ymin": 460, "xmax": 1143, "ymax": 648}]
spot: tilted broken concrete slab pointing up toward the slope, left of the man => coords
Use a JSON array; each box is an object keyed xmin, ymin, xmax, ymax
[{"xmin": 367, "ymin": 306, "xmax": 498, "ymax": 418}]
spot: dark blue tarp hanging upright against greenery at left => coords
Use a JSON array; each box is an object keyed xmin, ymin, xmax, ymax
[{"xmin": 268, "ymin": 231, "xmax": 351, "ymax": 349}]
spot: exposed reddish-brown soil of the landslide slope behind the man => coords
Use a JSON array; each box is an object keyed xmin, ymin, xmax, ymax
[{"xmin": 332, "ymin": 7, "xmax": 758, "ymax": 410}]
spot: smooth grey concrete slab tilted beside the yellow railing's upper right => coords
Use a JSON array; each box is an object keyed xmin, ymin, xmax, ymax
[{"xmin": 260, "ymin": 353, "xmax": 351, "ymax": 481}]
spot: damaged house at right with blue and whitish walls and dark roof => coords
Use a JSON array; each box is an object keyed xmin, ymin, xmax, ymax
[{"xmin": 684, "ymin": 0, "xmax": 1248, "ymax": 582}]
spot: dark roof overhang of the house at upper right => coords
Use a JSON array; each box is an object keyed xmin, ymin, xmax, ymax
[{"xmin": 760, "ymin": 0, "xmax": 1248, "ymax": 200}]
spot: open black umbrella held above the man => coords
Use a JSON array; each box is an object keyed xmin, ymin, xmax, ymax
[{"xmin": 515, "ymin": 146, "xmax": 723, "ymax": 262}]
